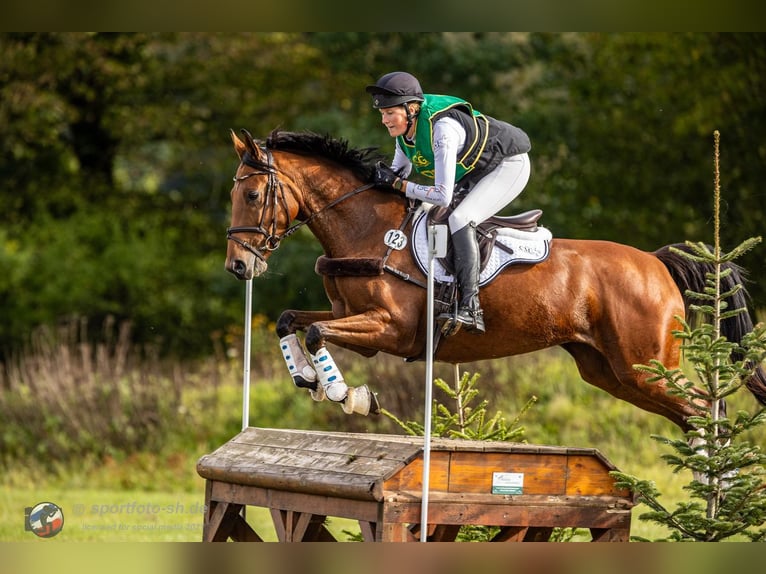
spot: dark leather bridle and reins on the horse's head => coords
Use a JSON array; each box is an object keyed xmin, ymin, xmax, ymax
[{"xmin": 226, "ymin": 149, "xmax": 375, "ymax": 262}]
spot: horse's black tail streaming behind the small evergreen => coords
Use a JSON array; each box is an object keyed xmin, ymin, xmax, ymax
[{"xmin": 654, "ymin": 243, "xmax": 766, "ymax": 405}]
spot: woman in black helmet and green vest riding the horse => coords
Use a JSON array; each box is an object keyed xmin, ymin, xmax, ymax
[{"xmin": 366, "ymin": 72, "xmax": 531, "ymax": 333}]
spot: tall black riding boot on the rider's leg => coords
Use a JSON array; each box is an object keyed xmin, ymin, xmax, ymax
[{"xmin": 440, "ymin": 224, "xmax": 484, "ymax": 333}]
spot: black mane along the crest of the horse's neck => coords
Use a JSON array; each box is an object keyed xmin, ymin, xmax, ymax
[{"xmin": 264, "ymin": 130, "xmax": 382, "ymax": 181}]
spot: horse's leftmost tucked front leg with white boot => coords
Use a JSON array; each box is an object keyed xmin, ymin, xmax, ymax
[{"xmin": 277, "ymin": 309, "xmax": 333, "ymax": 401}]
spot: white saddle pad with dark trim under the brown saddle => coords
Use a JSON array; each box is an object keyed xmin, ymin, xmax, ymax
[{"xmin": 410, "ymin": 211, "xmax": 553, "ymax": 285}]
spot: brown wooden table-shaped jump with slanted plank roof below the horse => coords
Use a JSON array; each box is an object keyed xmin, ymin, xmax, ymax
[{"xmin": 197, "ymin": 427, "xmax": 635, "ymax": 542}]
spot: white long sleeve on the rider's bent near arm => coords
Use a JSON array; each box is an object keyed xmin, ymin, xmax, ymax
[{"xmin": 399, "ymin": 118, "xmax": 466, "ymax": 207}]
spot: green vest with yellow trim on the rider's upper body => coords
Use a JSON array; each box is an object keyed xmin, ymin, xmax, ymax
[{"xmin": 397, "ymin": 94, "xmax": 489, "ymax": 181}]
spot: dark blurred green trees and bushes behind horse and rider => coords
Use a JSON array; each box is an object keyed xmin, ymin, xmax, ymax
[{"xmin": 0, "ymin": 32, "xmax": 766, "ymax": 357}]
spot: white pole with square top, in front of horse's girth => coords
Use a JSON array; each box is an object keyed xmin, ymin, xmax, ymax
[{"xmin": 420, "ymin": 225, "xmax": 447, "ymax": 542}]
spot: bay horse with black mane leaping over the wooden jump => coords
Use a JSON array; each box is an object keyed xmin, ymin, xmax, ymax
[{"xmin": 226, "ymin": 130, "xmax": 766, "ymax": 430}]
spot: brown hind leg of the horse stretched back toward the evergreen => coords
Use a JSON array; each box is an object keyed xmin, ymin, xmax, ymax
[{"xmin": 562, "ymin": 343, "xmax": 698, "ymax": 431}]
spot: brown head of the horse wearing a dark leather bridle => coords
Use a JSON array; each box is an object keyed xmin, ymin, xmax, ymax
[{"xmin": 226, "ymin": 130, "xmax": 297, "ymax": 279}]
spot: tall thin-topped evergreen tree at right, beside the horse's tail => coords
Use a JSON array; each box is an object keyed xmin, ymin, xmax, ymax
[{"xmin": 611, "ymin": 131, "xmax": 766, "ymax": 542}]
